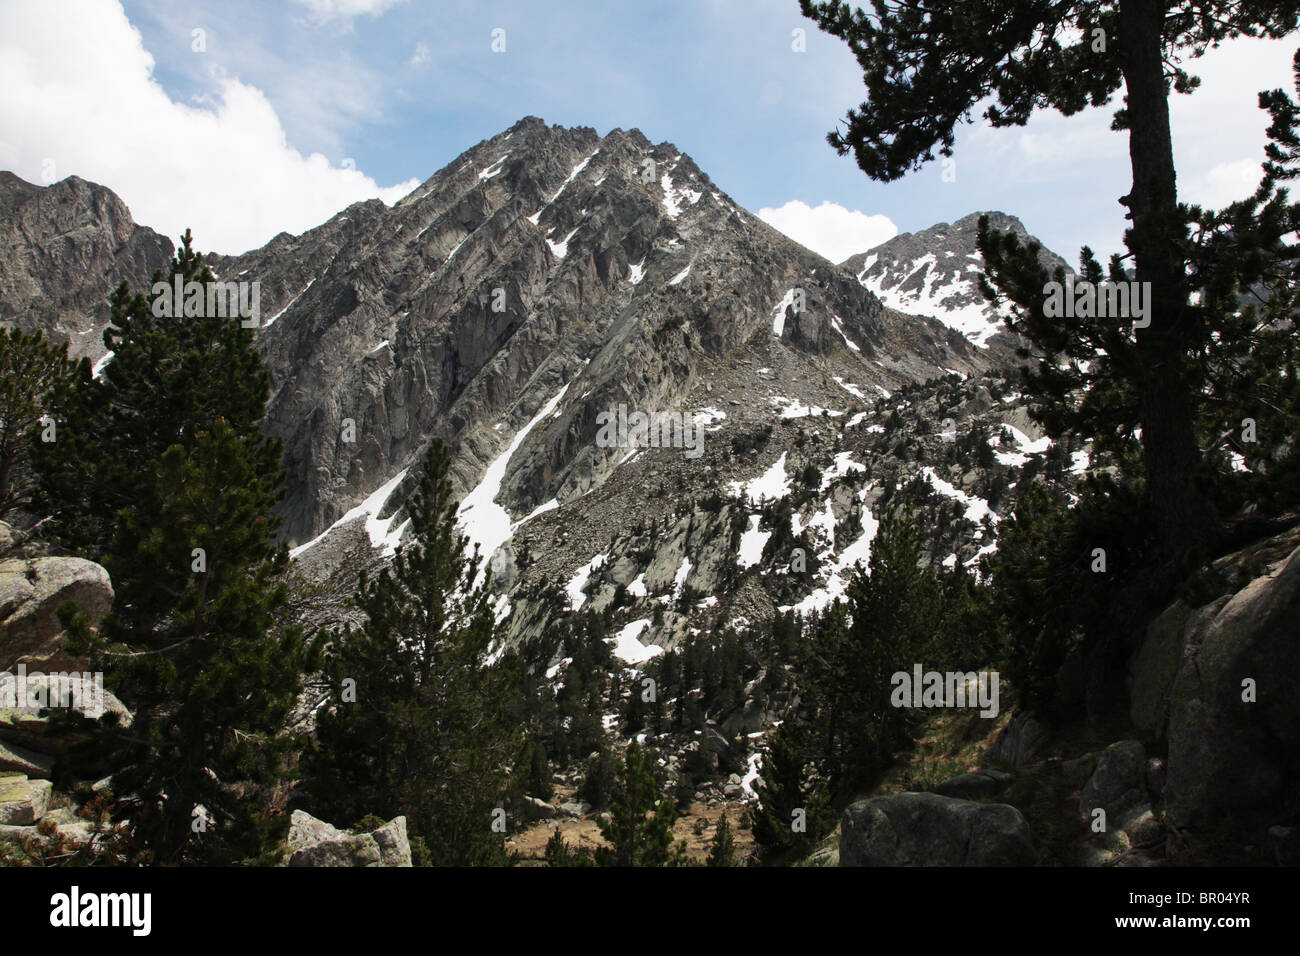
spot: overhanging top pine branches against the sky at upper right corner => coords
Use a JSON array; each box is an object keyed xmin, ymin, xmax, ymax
[{"xmin": 800, "ymin": 0, "xmax": 1297, "ymax": 182}]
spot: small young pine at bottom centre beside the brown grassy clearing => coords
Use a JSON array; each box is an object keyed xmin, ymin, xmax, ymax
[{"xmin": 597, "ymin": 740, "xmax": 683, "ymax": 866}]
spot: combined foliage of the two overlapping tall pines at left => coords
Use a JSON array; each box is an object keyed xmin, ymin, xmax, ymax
[{"xmin": 42, "ymin": 233, "xmax": 313, "ymax": 864}]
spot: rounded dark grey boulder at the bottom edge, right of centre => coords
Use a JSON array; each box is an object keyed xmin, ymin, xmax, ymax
[{"xmin": 840, "ymin": 793, "xmax": 1035, "ymax": 866}]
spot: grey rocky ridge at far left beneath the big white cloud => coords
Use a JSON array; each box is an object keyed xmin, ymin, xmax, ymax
[{"xmin": 0, "ymin": 170, "xmax": 173, "ymax": 362}]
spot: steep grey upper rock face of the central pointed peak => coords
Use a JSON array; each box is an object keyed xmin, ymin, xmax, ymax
[{"xmin": 212, "ymin": 117, "xmax": 980, "ymax": 554}]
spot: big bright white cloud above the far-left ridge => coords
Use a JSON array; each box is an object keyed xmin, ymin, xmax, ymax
[{"xmin": 0, "ymin": 0, "xmax": 417, "ymax": 252}]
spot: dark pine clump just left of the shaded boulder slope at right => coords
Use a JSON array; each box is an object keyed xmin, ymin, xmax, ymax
[{"xmin": 753, "ymin": 507, "xmax": 1001, "ymax": 861}]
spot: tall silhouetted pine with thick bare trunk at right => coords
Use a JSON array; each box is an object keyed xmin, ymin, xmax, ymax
[{"xmin": 801, "ymin": 0, "xmax": 1300, "ymax": 711}]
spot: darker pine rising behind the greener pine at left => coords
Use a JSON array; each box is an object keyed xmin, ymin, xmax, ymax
[{"xmin": 34, "ymin": 230, "xmax": 280, "ymax": 556}]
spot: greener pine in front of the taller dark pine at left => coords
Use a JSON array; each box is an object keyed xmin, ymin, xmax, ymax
[{"xmin": 82, "ymin": 420, "xmax": 312, "ymax": 862}]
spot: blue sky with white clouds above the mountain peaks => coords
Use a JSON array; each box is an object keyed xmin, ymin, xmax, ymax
[{"xmin": 0, "ymin": 0, "xmax": 1297, "ymax": 260}]
